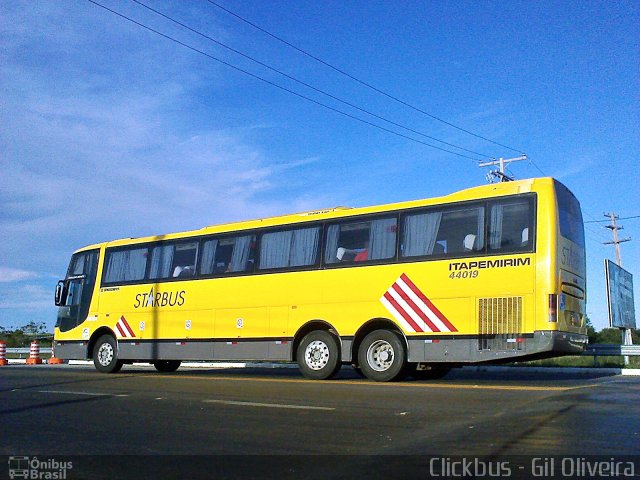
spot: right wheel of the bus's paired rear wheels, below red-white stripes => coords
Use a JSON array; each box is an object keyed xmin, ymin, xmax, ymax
[{"xmin": 358, "ymin": 330, "xmax": 407, "ymax": 382}]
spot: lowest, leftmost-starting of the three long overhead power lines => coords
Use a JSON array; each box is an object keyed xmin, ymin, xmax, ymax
[{"xmin": 87, "ymin": 0, "xmax": 480, "ymax": 162}]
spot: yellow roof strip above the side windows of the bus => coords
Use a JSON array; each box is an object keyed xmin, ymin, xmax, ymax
[{"xmin": 75, "ymin": 177, "xmax": 554, "ymax": 253}]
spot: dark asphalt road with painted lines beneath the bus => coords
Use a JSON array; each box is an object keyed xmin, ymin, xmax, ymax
[{"xmin": 0, "ymin": 365, "xmax": 640, "ymax": 478}]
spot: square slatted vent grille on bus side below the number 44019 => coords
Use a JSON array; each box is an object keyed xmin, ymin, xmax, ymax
[{"xmin": 478, "ymin": 297, "xmax": 522, "ymax": 351}]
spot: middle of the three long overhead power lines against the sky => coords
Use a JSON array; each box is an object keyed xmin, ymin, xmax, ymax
[{"xmin": 131, "ymin": 0, "xmax": 493, "ymax": 159}]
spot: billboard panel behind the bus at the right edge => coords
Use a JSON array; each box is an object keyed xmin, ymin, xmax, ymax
[{"xmin": 604, "ymin": 260, "xmax": 636, "ymax": 328}]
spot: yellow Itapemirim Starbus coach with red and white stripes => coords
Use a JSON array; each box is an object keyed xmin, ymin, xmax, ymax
[{"xmin": 55, "ymin": 178, "xmax": 587, "ymax": 381}]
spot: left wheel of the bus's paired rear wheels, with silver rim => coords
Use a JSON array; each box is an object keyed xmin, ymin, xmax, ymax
[{"xmin": 296, "ymin": 330, "xmax": 342, "ymax": 380}]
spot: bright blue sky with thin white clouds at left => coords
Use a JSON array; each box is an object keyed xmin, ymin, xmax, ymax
[{"xmin": 0, "ymin": 0, "xmax": 640, "ymax": 328}]
